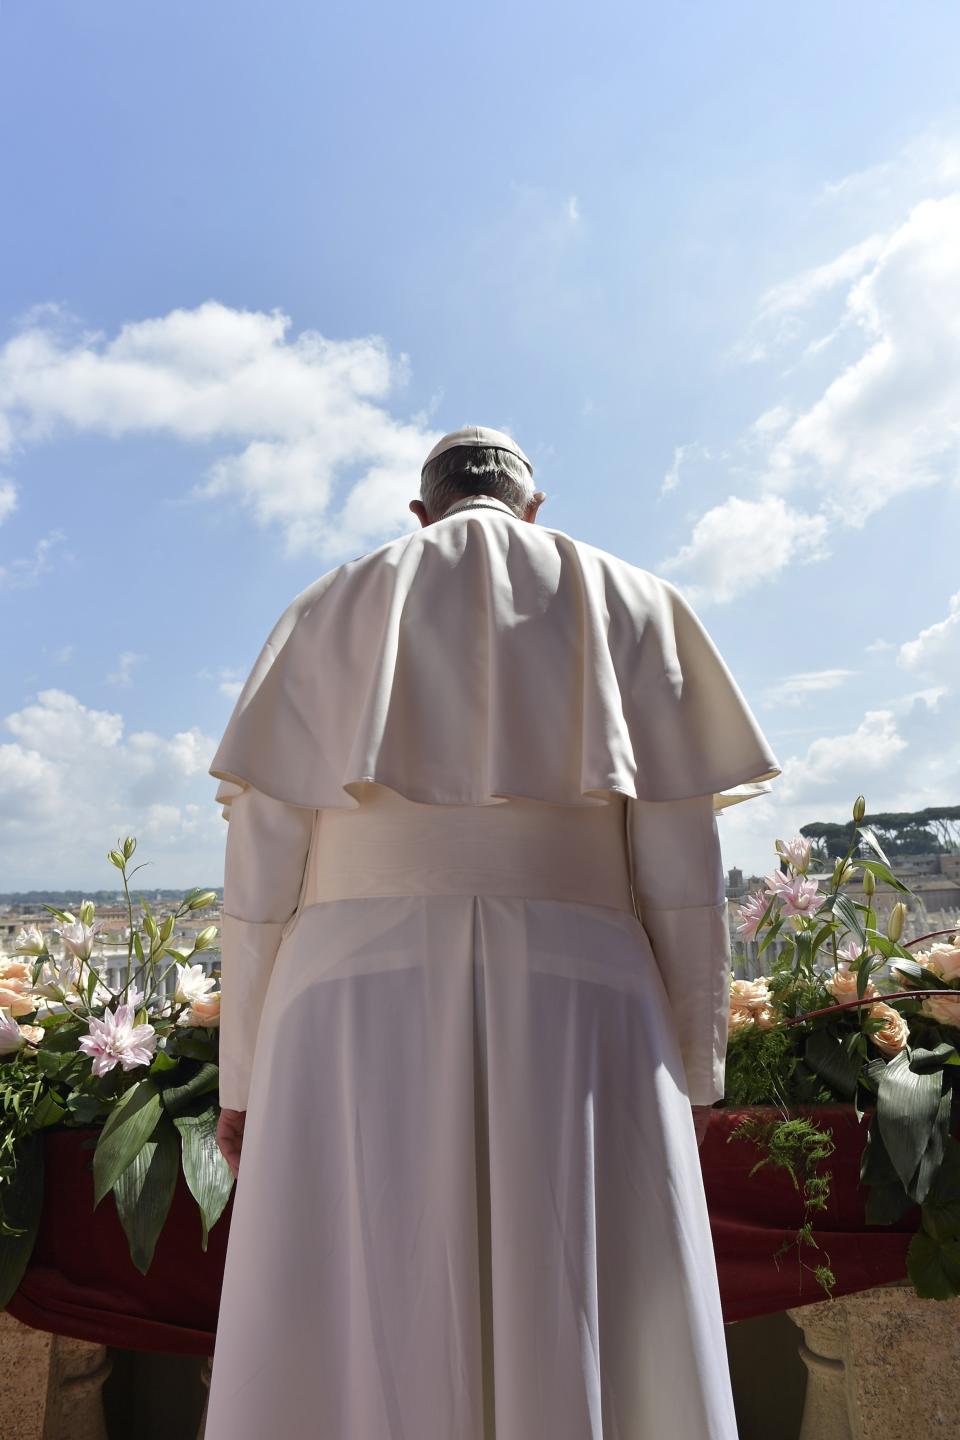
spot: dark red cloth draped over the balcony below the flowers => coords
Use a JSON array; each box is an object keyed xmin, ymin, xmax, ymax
[{"xmin": 7, "ymin": 1106, "xmax": 920, "ymax": 1355}]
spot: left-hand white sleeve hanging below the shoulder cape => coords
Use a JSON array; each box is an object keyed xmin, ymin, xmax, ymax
[{"xmin": 219, "ymin": 785, "xmax": 317, "ymax": 1110}]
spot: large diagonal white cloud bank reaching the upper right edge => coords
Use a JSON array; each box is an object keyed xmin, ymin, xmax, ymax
[{"xmin": 664, "ymin": 175, "xmax": 960, "ymax": 600}]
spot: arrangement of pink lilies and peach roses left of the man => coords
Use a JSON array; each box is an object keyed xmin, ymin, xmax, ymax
[{"xmin": 0, "ymin": 837, "xmax": 233, "ymax": 1309}]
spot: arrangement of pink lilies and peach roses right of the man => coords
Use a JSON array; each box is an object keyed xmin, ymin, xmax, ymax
[{"xmin": 724, "ymin": 795, "xmax": 960, "ymax": 1299}]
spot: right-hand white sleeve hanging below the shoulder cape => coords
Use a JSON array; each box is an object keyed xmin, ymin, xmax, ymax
[{"xmin": 628, "ymin": 795, "xmax": 731, "ymax": 1104}]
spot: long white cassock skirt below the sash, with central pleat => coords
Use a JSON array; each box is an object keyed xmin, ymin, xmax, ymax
[{"xmin": 206, "ymin": 894, "xmax": 737, "ymax": 1440}]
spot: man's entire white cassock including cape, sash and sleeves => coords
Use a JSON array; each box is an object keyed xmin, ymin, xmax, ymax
[{"xmin": 206, "ymin": 497, "xmax": 780, "ymax": 1440}]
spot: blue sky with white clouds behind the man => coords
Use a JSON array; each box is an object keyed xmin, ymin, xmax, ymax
[{"xmin": 0, "ymin": 0, "xmax": 960, "ymax": 890}]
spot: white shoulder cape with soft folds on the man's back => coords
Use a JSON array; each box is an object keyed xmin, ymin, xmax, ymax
[{"xmin": 209, "ymin": 508, "xmax": 782, "ymax": 819}]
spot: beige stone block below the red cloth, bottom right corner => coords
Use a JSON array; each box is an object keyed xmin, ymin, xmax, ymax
[{"xmin": 786, "ymin": 1280, "xmax": 960, "ymax": 1440}]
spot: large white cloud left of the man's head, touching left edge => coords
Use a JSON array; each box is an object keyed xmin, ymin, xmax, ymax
[{"xmin": 0, "ymin": 301, "xmax": 440, "ymax": 559}]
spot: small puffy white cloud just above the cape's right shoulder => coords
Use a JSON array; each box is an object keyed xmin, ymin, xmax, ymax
[{"xmin": 659, "ymin": 495, "xmax": 826, "ymax": 605}]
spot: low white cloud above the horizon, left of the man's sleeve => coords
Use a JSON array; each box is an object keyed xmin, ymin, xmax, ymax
[{"xmin": 0, "ymin": 690, "xmax": 225, "ymax": 890}]
